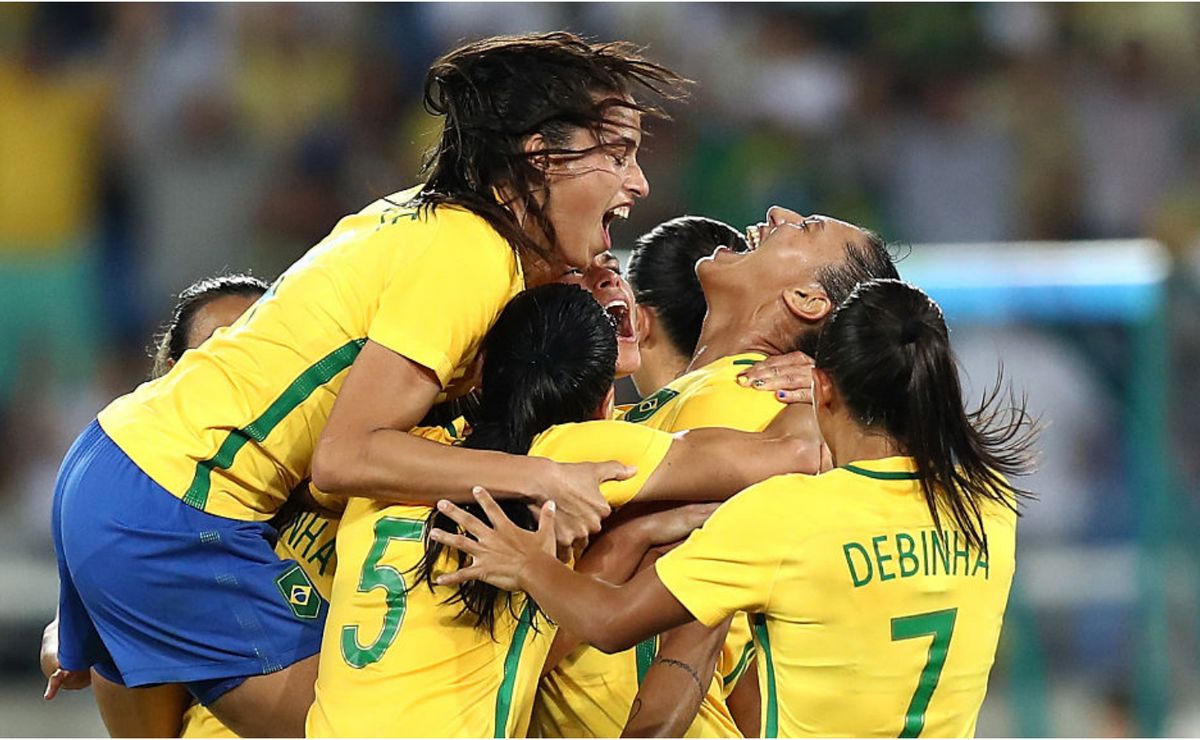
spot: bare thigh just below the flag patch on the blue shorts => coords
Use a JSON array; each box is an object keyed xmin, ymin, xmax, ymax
[{"xmin": 209, "ymin": 655, "xmax": 319, "ymax": 738}]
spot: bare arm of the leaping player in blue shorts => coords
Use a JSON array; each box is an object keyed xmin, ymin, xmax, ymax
[{"xmin": 312, "ymin": 341, "xmax": 630, "ymax": 542}]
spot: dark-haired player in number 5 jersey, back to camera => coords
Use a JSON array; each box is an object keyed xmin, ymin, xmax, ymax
[{"xmin": 307, "ymin": 285, "xmax": 816, "ymax": 736}]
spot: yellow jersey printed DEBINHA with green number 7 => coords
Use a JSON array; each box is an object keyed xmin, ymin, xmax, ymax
[{"xmin": 655, "ymin": 457, "xmax": 1016, "ymax": 738}]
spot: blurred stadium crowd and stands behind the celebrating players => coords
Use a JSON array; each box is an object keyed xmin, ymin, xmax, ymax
[{"xmin": 0, "ymin": 4, "xmax": 1200, "ymax": 735}]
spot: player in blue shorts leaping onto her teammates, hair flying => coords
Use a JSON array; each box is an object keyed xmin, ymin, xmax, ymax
[{"xmin": 53, "ymin": 34, "xmax": 679, "ymax": 735}]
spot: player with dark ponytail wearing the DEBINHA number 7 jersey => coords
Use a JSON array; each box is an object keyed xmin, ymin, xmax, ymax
[{"xmin": 431, "ymin": 281, "xmax": 1033, "ymax": 736}]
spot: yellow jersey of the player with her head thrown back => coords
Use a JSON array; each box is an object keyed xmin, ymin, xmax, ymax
[{"xmin": 533, "ymin": 353, "xmax": 785, "ymax": 738}]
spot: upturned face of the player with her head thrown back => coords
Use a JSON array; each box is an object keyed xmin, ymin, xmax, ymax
[{"xmin": 696, "ymin": 205, "xmax": 866, "ymax": 299}]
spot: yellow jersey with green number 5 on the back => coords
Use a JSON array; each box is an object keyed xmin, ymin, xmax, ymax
[{"xmin": 307, "ymin": 420, "xmax": 671, "ymax": 738}]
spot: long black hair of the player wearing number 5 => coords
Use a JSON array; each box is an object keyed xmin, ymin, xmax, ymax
[{"xmin": 413, "ymin": 283, "xmax": 617, "ymax": 633}]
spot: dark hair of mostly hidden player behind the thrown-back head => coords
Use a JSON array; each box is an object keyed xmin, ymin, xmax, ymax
[{"xmin": 629, "ymin": 216, "xmax": 750, "ymax": 357}]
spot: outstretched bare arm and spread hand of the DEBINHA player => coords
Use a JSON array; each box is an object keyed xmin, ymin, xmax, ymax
[{"xmin": 430, "ymin": 488, "xmax": 692, "ymax": 652}]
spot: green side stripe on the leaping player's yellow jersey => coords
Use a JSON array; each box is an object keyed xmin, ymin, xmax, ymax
[{"xmin": 182, "ymin": 337, "xmax": 367, "ymax": 511}]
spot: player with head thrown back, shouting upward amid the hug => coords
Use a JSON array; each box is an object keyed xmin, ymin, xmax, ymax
[{"xmin": 534, "ymin": 206, "xmax": 896, "ymax": 736}]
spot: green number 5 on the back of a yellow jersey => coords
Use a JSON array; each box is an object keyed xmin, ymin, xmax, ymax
[{"xmin": 342, "ymin": 517, "xmax": 425, "ymax": 668}]
